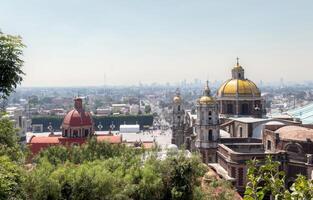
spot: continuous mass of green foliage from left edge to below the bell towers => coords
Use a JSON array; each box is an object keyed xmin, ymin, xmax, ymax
[{"xmin": 0, "ymin": 115, "xmax": 236, "ymax": 200}]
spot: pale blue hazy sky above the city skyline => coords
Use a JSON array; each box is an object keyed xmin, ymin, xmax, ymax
[{"xmin": 0, "ymin": 0, "xmax": 313, "ymax": 86}]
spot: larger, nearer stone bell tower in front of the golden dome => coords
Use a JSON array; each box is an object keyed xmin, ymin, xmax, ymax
[{"xmin": 195, "ymin": 81, "xmax": 220, "ymax": 163}]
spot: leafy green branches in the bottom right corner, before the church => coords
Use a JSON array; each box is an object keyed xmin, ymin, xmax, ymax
[{"xmin": 244, "ymin": 157, "xmax": 313, "ymax": 200}]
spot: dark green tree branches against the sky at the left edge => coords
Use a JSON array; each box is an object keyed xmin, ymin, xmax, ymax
[{"xmin": 0, "ymin": 32, "xmax": 25, "ymax": 98}]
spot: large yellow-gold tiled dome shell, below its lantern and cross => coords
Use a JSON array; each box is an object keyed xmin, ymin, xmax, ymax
[{"xmin": 217, "ymin": 79, "xmax": 261, "ymax": 97}]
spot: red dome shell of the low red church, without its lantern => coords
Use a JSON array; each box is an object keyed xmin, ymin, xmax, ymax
[{"xmin": 62, "ymin": 109, "xmax": 92, "ymax": 126}]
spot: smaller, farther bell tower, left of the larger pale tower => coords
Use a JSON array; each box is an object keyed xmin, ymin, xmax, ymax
[{"xmin": 172, "ymin": 89, "xmax": 185, "ymax": 147}]
